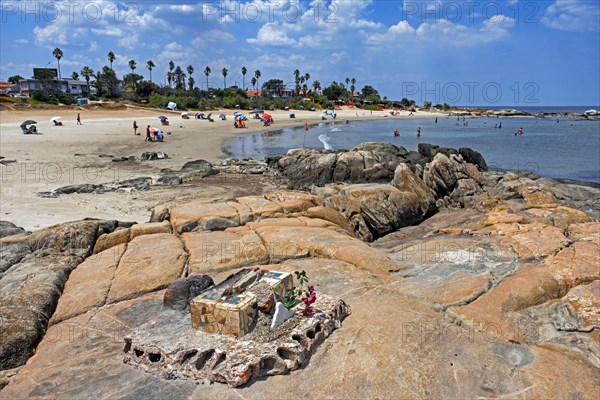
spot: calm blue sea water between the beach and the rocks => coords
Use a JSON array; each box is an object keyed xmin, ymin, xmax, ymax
[{"xmin": 227, "ymin": 115, "xmax": 600, "ymax": 184}]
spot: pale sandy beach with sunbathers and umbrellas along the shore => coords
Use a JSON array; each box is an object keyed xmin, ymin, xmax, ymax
[{"xmin": 0, "ymin": 107, "xmax": 439, "ymax": 230}]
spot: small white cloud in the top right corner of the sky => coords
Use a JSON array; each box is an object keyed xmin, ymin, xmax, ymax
[{"xmin": 542, "ymin": 0, "xmax": 600, "ymax": 31}]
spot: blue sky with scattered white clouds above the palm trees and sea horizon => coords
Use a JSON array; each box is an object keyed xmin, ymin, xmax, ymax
[{"xmin": 0, "ymin": 0, "xmax": 600, "ymax": 107}]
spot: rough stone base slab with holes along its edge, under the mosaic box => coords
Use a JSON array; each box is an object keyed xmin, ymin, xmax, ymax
[{"xmin": 123, "ymin": 294, "xmax": 350, "ymax": 387}]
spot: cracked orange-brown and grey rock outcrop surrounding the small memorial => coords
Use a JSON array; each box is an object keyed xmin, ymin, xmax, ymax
[{"xmin": 0, "ymin": 144, "xmax": 600, "ymax": 399}]
